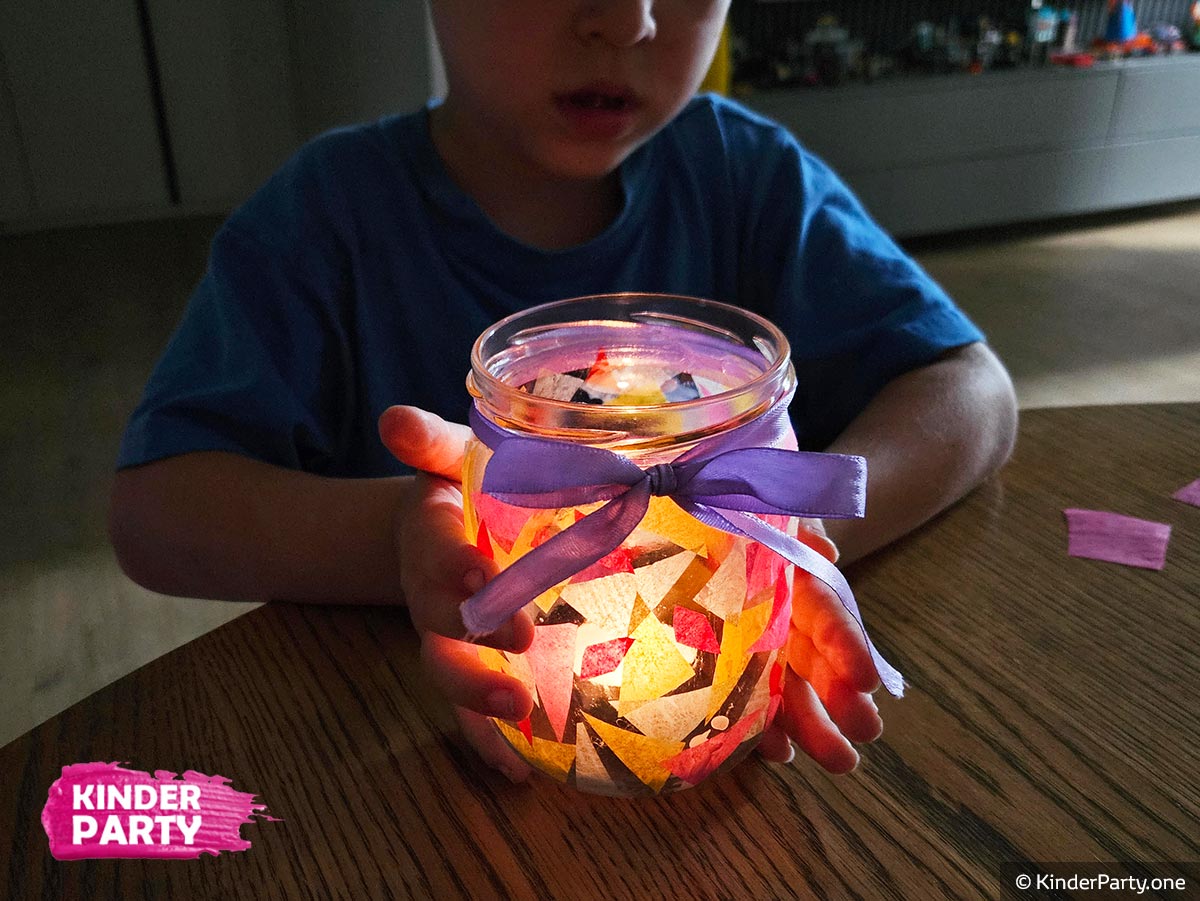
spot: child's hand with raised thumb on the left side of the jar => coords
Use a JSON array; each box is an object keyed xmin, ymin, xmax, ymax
[{"xmin": 379, "ymin": 407, "xmax": 533, "ymax": 781}]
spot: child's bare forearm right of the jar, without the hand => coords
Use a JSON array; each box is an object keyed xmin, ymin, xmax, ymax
[{"xmin": 824, "ymin": 344, "xmax": 1016, "ymax": 563}]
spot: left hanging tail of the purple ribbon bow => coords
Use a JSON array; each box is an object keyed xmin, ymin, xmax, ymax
[{"xmin": 461, "ymin": 480, "xmax": 650, "ymax": 639}]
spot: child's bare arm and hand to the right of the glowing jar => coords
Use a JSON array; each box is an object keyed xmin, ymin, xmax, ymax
[{"xmin": 760, "ymin": 344, "xmax": 1016, "ymax": 773}]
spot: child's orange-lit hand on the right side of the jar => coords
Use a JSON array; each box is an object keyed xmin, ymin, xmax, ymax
[{"xmin": 758, "ymin": 519, "xmax": 883, "ymax": 773}]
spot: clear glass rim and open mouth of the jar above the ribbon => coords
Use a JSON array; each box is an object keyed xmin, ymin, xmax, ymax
[{"xmin": 467, "ymin": 294, "xmax": 794, "ymax": 446}]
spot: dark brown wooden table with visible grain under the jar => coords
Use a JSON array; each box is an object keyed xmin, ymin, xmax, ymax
[{"xmin": 0, "ymin": 404, "xmax": 1200, "ymax": 899}]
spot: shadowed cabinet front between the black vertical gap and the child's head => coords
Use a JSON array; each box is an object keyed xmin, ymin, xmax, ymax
[{"xmin": 148, "ymin": 0, "xmax": 430, "ymax": 210}]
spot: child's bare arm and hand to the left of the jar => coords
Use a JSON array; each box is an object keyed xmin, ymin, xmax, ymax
[{"xmin": 109, "ymin": 408, "xmax": 533, "ymax": 779}]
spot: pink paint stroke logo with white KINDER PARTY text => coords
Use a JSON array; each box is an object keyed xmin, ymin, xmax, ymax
[{"xmin": 42, "ymin": 763, "xmax": 278, "ymax": 860}]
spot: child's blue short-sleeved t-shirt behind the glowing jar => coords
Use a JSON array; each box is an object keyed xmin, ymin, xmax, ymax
[{"xmin": 119, "ymin": 96, "xmax": 982, "ymax": 476}]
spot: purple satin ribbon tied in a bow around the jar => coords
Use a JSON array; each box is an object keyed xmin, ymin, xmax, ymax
[{"xmin": 462, "ymin": 396, "xmax": 904, "ymax": 697}]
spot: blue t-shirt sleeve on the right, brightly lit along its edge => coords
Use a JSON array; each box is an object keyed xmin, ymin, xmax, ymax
[{"xmin": 743, "ymin": 130, "xmax": 983, "ymax": 449}]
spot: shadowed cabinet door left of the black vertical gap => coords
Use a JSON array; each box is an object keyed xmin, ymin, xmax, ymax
[{"xmin": 0, "ymin": 0, "xmax": 169, "ymax": 218}]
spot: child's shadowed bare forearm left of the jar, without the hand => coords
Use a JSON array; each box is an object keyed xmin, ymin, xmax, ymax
[{"xmin": 109, "ymin": 452, "xmax": 412, "ymax": 603}]
